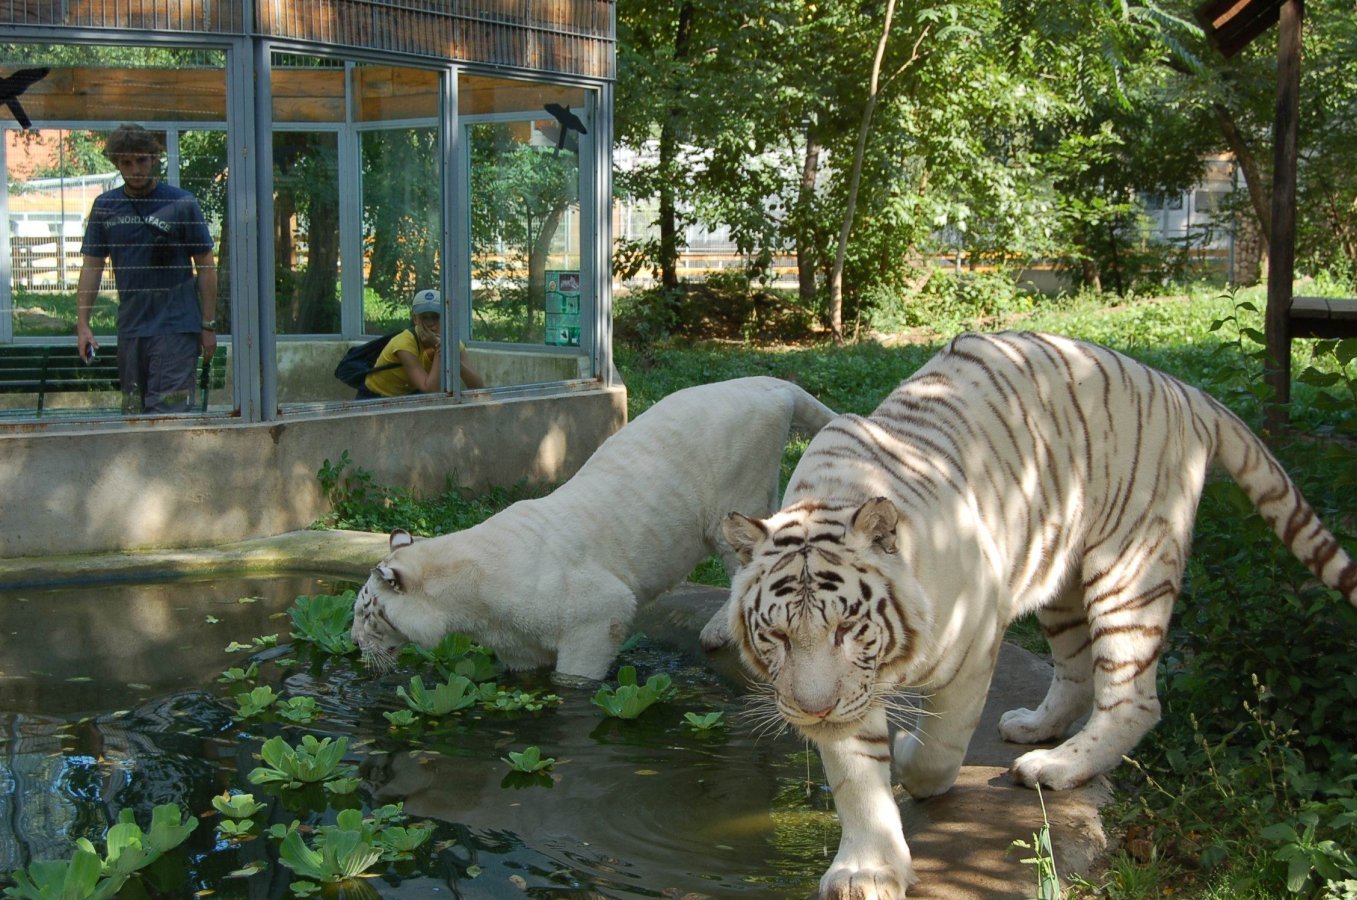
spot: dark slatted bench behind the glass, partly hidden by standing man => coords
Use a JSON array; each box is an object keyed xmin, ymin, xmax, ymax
[{"xmin": 0, "ymin": 341, "xmax": 227, "ymax": 418}]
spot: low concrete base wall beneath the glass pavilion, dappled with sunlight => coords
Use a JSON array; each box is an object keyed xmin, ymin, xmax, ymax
[{"xmin": 0, "ymin": 387, "xmax": 627, "ymax": 558}]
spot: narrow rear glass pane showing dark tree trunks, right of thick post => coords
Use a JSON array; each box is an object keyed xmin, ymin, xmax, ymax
[{"xmin": 273, "ymin": 132, "xmax": 339, "ymax": 335}]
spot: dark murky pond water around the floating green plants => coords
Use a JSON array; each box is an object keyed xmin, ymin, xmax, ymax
[{"xmin": 0, "ymin": 578, "xmax": 839, "ymax": 899}]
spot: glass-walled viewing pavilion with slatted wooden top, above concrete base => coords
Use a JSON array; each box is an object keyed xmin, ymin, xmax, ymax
[{"xmin": 0, "ymin": 0, "xmax": 615, "ymax": 423}]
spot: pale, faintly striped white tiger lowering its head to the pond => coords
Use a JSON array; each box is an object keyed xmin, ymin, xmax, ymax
[{"xmin": 353, "ymin": 377, "xmax": 835, "ymax": 679}]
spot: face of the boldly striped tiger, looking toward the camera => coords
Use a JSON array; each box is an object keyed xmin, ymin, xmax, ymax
[{"xmin": 725, "ymin": 498, "xmax": 917, "ymax": 737}]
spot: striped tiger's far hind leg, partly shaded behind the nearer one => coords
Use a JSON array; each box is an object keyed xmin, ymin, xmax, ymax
[{"xmin": 999, "ymin": 586, "xmax": 1094, "ymax": 744}]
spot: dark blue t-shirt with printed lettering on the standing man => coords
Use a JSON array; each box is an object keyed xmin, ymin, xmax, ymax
[{"xmin": 80, "ymin": 182, "xmax": 212, "ymax": 338}]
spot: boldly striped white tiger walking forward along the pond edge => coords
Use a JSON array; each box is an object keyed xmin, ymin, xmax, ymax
[{"xmin": 726, "ymin": 333, "xmax": 1357, "ymax": 900}]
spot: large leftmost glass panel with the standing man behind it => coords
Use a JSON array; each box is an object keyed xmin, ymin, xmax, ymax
[{"xmin": 0, "ymin": 43, "xmax": 233, "ymax": 418}]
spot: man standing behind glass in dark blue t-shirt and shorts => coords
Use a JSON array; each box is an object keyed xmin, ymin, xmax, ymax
[{"xmin": 76, "ymin": 125, "xmax": 217, "ymax": 413}]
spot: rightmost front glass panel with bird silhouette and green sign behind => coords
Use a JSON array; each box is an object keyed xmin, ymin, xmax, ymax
[{"xmin": 459, "ymin": 77, "xmax": 594, "ymax": 386}]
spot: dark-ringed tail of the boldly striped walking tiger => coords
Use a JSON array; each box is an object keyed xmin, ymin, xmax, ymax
[{"xmin": 1208, "ymin": 396, "xmax": 1357, "ymax": 607}]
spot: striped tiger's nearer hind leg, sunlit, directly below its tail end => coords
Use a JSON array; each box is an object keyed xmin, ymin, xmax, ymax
[{"xmin": 1012, "ymin": 531, "xmax": 1187, "ymax": 790}]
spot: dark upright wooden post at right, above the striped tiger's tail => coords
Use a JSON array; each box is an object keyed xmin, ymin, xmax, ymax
[{"xmin": 1263, "ymin": 0, "xmax": 1304, "ymax": 430}]
